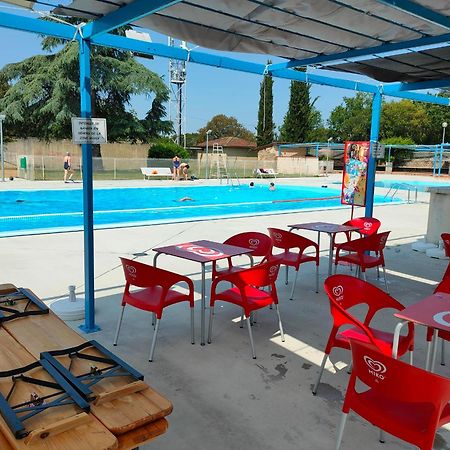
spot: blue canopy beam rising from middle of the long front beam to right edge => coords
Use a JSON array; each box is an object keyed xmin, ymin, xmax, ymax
[{"xmin": 268, "ymin": 33, "xmax": 450, "ymax": 73}]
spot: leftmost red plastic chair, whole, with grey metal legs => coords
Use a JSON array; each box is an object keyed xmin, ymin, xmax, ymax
[{"xmin": 113, "ymin": 258, "xmax": 194, "ymax": 361}]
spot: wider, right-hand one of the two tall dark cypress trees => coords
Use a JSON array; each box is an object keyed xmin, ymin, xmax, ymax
[{"xmin": 280, "ymin": 71, "xmax": 312, "ymax": 142}]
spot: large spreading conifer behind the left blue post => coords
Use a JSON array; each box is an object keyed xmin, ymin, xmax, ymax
[{"xmin": 0, "ymin": 24, "xmax": 168, "ymax": 149}]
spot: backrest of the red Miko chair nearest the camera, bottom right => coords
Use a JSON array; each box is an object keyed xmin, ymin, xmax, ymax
[{"xmin": 349, "ymin": 341, "xmax": 450, "ymax": 414}]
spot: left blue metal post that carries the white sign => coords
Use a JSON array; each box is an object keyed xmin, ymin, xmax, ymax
[{"xmin": 79, "ymin": 38, "xmax": 100, "ymax": 333}]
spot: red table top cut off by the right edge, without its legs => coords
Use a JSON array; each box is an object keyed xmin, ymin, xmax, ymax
[{"xmin": 394, "ymin": 292, "xmax": 450, "ymax": 331}]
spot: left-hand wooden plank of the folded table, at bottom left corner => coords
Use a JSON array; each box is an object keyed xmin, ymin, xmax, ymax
[{"xmin": 0, "ymin": 329, "xmax": 118, "ymax": 450}]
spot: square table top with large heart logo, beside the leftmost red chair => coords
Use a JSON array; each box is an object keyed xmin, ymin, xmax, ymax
[{"xmin": 153, "ymin": 241, "xmax": 253, "ymax": 263}]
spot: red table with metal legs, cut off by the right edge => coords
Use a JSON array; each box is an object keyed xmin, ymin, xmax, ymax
[{"xmin": 392, "ymin": 292, "xmax": 450, "ymax": 372}]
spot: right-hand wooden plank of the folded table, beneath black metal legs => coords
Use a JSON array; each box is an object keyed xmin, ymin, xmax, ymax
[{"xmin": 0, "ymin": 286, "xmax": 172, "ymax": 435}]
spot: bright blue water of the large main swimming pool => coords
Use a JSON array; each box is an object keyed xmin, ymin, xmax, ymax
[{"xmin": 0, "ymin": 184, "xmax": 400, "ymax": 236}]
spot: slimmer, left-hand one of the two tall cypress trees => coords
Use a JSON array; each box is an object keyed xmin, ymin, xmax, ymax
[{"xmin": 256, "ymin": 61, "xmax": 275, "ymax": 146}]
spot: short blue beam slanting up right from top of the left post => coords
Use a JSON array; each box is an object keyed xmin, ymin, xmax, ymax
[{"xmin": 83, "ymin": 0, "xmax": 181, "ymax": 39}]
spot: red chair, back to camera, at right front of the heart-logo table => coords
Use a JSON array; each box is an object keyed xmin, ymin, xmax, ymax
[{"xmin": 208, "ymin": 261, "xmax": 284, "ymax": 359}]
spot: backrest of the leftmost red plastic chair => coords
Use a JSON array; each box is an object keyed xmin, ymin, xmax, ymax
[{"xmin": 120, "ymin": 258, "xmax": 180, "ymax": 288}]
